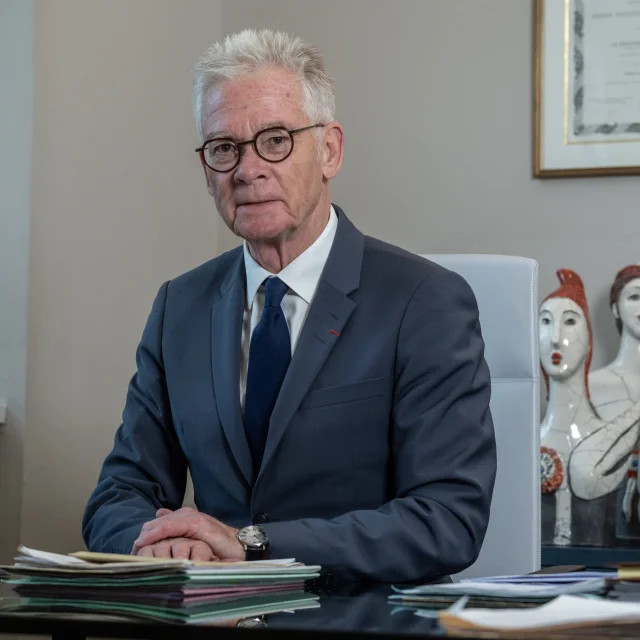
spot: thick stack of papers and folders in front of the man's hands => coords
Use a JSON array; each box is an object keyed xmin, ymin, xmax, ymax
[{"xmin": 0, "ymin": 546, "xmax": 320, "ymax": 624}]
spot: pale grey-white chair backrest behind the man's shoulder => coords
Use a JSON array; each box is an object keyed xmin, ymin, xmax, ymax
[{"xmin": 424, "ymin": 254, "xmax": 540, "ymax": 579}]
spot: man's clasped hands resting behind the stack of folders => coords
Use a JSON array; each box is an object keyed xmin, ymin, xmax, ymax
[{"xmin": 131, "ymin": 507, "xmax": 245, "ymax": 562}]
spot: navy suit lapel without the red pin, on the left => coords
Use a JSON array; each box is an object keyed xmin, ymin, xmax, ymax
[{"xmin": 211, "ymin": 252, "xmax": 253, "ymax": 486}]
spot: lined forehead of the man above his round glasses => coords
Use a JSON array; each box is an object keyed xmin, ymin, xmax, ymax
[{"xmin": 202, "ymin": 69, "xmax": 305, "ymax": 137}]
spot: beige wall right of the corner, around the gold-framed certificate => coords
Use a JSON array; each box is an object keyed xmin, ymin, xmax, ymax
[{"xmin": 221, "ymin": 0, "xmax": 640, "ymax": 366}]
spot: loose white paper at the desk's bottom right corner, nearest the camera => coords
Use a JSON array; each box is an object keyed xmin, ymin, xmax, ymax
[{"xmin": 440, "ymin": 596, "xmax": 640, "ymax": 633}]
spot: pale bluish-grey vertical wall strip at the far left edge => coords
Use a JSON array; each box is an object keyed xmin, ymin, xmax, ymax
[{"xmin": 0, "ymin": 0, "xmax": 34, "ymax": 563}]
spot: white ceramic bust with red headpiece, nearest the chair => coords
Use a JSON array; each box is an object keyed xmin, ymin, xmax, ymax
[{"xmin": 539, "ymin": 269, "xmax": 640, "ymax": 546}]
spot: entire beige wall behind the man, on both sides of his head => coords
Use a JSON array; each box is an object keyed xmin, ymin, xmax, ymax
[{"xmin": 7, "ymin": 0, "xmax": 640, "ymax": 550}]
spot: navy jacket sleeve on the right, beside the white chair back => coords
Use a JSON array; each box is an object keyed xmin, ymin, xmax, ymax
[{"xmin": 263, "ymin": 271, "xmax": 496, "ymax": 582}]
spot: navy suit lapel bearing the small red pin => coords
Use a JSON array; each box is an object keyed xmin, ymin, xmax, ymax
[{"xmin": 256, "ymin": 205, "xmax": 364, "ymax": 484}]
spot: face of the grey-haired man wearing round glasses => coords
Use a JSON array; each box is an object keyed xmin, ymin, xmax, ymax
[{"xmin": 202, "ymin": 69, "xmax": 325, "ymax": 241}]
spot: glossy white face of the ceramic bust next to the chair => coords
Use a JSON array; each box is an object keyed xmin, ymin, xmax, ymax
[{"xmin": 539, "ymin": 298, "xmax": 592, "ymax": 380}]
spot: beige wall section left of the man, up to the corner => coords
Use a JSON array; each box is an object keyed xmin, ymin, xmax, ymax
[{"xmin": 22, "ymin": 0, "xmax": 220, "ymax": 551}]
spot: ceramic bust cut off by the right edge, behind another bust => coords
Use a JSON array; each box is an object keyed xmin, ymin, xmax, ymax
[{"xmin": 589, "ymin": 264, "xmax": 640, "ymax": 540}]
